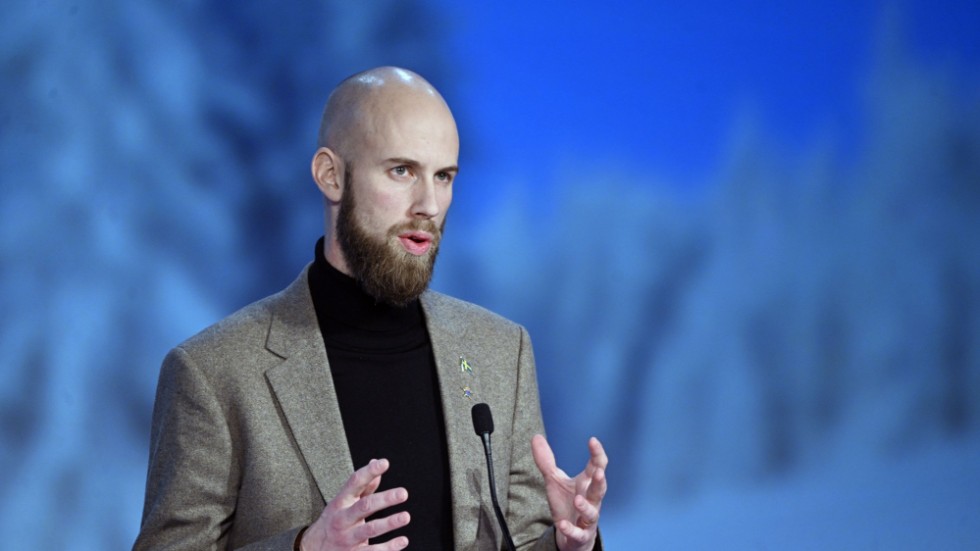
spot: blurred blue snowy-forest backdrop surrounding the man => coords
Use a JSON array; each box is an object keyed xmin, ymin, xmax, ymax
[{"xmin": 0, "ymin": 0, "xmax": 980, "ymax": 549}]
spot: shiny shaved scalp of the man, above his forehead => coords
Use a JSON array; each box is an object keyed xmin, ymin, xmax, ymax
[{"xmin": 317, "ymin": 67, "xmax": 455, "ymax": 158}]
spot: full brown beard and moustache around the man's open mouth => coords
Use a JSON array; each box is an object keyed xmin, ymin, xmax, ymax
[{"xmin": 337, "ymin": 165, "xmax": 446, "ymax": 306}]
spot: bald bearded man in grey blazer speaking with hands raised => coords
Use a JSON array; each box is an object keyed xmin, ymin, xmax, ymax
[{"xmin": 134, "ymin": 67, "xmax": 607, "ymax": 551}]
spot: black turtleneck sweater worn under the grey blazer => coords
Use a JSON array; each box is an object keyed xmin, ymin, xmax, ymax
[{"xmin": 309, "ymin": 238, "xmax": 453, "ymax": 549}]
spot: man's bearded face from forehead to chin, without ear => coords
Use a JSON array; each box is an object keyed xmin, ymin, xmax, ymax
[{"xmin": 336, "ymin": 93, "xmax": 458, "ymax": 305}]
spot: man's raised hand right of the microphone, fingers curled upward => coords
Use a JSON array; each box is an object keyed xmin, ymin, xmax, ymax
[{"xmin": 531, "ymin": 434, "xmax": 609, "ymax": 551}]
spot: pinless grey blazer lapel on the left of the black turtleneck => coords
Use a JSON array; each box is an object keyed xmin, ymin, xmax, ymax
[{"xmin": 266, "ymin": 268, "xmax": 354, "ymax": 502}]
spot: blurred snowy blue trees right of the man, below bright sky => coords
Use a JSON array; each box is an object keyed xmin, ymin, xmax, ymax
[{"xmin": 440, "ymin": 14, "xmax": 980, "ymax": 503}]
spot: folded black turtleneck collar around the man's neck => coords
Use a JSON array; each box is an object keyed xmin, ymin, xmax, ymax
[{"xmin": 308, "ymin": 237, "xmax": 426, "ymax": 350}]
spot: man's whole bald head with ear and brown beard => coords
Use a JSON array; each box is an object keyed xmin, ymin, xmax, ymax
[{"xmin": 311, "ymin": 67, "xmax": 459, "ymax": 288}]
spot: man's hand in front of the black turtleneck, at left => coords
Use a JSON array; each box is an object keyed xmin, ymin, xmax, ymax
[{"xmin": 300, "ymin": 459, "xmax": 411, "ymax": 551}]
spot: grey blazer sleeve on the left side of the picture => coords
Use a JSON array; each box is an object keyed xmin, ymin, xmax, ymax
[{"xmin": 133, "ymin": 347, "xmax": 300, "ymax": 551}]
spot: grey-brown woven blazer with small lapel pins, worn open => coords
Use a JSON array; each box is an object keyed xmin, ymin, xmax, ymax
[{"xmin": 134, "ymin": 266, "xmax": 555, "ymax": 550}]
